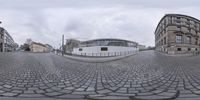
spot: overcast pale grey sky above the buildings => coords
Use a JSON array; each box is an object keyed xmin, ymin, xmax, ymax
[{"xmin": 0, "ymin": 0, "xmax": 200, "ymax": 47}]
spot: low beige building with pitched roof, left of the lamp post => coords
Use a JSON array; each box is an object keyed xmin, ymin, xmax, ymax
[{"xmin": 29, "ymin": 42, "xmax": 49, "ymax": 52}]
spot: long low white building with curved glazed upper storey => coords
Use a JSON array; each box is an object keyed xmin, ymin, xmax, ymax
[{"xmin": 72, "ymin": 39, "xmax": 138, "ymax": 56}]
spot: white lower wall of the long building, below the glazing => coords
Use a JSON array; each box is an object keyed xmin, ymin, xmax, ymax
[{"xmin": 72, "ymin": 46, "xmax": 138, "ymax": 56}]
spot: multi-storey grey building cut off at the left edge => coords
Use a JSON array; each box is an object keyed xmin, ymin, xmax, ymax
[{"xmin": 0, "ymin": 27, "xmax": 16, "ymax": 52}]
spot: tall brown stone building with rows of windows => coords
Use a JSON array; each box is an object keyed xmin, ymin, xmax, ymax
[{"xmin": 154, "ymin": 14, "xmax": 200, "ymax": 54}]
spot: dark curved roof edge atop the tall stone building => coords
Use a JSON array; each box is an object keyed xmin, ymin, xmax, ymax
[{"xmin": 154, "ymin": 14, "xmax": 200, "ymax": 34}]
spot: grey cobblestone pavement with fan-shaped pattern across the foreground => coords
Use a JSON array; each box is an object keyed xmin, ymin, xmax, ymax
[{"xmin": 0, "ymin": 51, "xmax": 200, "ymax": 100}]
